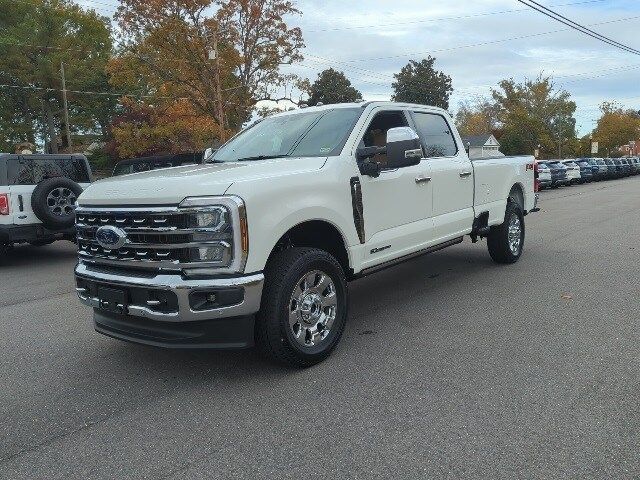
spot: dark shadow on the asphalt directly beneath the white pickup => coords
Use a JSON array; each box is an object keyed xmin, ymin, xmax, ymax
[{"xmin": 79, "ymin": 245, "xmax": 500, "ymax": 381}]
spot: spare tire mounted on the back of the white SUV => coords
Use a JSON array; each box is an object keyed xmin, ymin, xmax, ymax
[{"xmin": 31, "ymin": 177, "xmax": 82, "ymax": 230}]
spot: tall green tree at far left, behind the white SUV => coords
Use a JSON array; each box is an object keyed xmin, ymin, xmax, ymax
[{"xmin": 0, "ymin": 0, "xmax": 115, "ymax": 152}]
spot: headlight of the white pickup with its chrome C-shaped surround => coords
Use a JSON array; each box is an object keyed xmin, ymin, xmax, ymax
[{"xmin": 180, "ymin": 196, "xmax": 249, "ymax": 277}]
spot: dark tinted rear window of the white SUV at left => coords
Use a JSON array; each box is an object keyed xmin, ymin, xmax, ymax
[{"xmin": 7, "ymin": 155, "xmax": 91, "ymax": 185}]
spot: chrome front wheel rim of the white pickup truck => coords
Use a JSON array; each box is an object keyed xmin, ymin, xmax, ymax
[{"xmin": 289, "ymin": 270, "xmax": 338, "ymax": 347}]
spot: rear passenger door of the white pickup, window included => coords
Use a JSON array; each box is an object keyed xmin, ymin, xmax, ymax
[{"xmin": 412, "ymin": 109, "xmax": 474, "ymax": 243}]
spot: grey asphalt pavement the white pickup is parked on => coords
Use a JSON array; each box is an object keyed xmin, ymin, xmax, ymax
[{"xmin": 0, "ymin": 177, "xmax": 640, "ymax": 479}]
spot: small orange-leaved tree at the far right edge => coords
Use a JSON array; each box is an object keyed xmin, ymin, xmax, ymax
[{"xmin": 593, "ymin": 102, "xmax": 640, "ymax": 154}]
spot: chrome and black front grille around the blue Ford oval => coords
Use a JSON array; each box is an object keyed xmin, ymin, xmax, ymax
[{"xmin": 76, "ymin": 207, "xmax": 228, "ymax": 270}]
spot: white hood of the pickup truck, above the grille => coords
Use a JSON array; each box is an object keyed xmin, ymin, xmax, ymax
[{"xmin": 78, "ymin": 157, "xmax": 327, "ymax": 206}]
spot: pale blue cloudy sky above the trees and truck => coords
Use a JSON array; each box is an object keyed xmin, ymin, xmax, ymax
[{"xmin": 78, "ymin": 0, "xmax": 640, "ymax": 134}]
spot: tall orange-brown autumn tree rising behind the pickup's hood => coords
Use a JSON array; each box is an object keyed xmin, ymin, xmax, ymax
[{"xmin": 108, "ymin": 0, "xmax": 304, "ymax": 156}]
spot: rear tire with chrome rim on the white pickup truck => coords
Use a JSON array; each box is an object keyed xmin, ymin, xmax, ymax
[{"xmin": 487, "ymin": 201, "xmax": 525, "ymax": 264}]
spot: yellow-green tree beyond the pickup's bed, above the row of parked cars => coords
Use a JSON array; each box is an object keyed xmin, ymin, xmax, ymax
[{"xmin": 492, "ymin": 75, "xmax": 578, "ymax": 158}]
